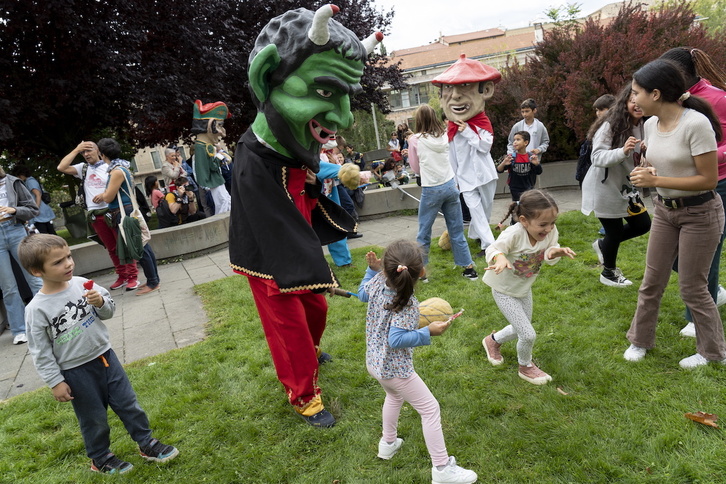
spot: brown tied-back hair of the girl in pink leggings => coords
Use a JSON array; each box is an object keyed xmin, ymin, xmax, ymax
[{"xmin": 383, "ymin": 240, "xmax": 423, "ymax": 312}]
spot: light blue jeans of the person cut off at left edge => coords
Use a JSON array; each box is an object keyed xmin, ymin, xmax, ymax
[{"xmin": 0, "ymin": 220, "xmax": 43, "ymax": 336}]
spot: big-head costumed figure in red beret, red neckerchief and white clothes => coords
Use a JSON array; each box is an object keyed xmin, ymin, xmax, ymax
[{"xmin": 431, "ymin": 54, "xmax": 502, "ymax": 255}]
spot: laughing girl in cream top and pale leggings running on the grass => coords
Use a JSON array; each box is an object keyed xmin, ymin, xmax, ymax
[{"xmin": 482, "ymin": 189, "xmax": 576, "ymax": 385}]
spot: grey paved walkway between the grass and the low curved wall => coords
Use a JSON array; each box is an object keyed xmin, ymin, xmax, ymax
[{"xmin": 0, "ymin": 189, "xmax": 580, "ymax": 401}]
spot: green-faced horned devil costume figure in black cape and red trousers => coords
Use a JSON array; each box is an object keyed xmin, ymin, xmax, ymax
[{"xmin": 229, "ymin": 5, "xmax": 383, "ymax": 427}]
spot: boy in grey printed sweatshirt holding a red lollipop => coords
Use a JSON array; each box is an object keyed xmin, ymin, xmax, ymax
[{"xmin": 18, "ymin": 234, "xmax": 179, "ymax": 474}]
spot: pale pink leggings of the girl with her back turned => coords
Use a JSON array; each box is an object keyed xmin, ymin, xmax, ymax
[{"xmin": 368, "ymin": 368, "xmax": 449, "ymax": 466}]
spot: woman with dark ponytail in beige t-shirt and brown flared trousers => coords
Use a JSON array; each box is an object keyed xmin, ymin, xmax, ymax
[{"xmin": 624, "ymin": 59, "xmax": 726, "ymax": 368}]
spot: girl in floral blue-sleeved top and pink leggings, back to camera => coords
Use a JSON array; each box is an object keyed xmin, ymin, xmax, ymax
[{"xmin": 358, "ymin": 240, "xmax": 477, "ymax": 484}]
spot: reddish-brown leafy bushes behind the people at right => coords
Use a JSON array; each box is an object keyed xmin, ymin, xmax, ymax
[{"xmin": 487, "ymin": 1, "xmax": 726, "ymax": 161}]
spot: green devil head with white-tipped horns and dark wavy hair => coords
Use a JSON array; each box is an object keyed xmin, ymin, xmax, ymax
[{"xmin": 248, "ymin": 5, "xmax": 383, "ymax": 173}]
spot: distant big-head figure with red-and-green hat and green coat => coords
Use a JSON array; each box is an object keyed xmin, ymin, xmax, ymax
[{"xmin": 192, "ymin": 99, "xmax": 232, "ymax": 214}]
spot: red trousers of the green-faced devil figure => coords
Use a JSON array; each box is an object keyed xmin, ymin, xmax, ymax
[{"xmin": 247, "ymin": 276, "xmax": 328, "ymax": 416}]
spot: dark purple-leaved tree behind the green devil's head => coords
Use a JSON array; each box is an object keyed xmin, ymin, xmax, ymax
[{"xmin": 0, "ymin": 0, "xmax": 403, "ymax": 173}]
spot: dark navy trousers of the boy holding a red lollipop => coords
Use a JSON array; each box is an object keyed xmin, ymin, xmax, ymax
[{"xmin": 61, "ymin": 350, "xmax": 151, "ymax": 460}]
